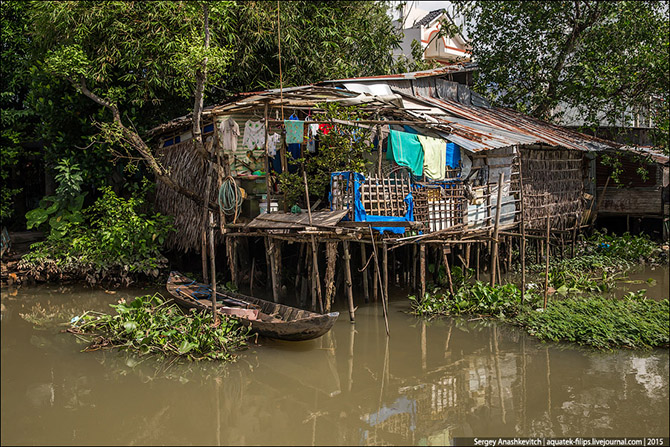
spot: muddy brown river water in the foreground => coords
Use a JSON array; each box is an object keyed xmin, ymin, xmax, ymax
[{"xmin": 1, "ymin": 269, "xmax": 670, "ymax": 445}]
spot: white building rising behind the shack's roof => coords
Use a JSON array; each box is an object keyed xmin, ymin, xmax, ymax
[{"xmin": 394, "ymin": 7, "xmax": 470, "ymax": 64}]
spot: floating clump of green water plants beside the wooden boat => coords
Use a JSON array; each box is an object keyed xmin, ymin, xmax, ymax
[{"xmin": 68, "ymin": 293, "xmax": 248, "ymax": 361}]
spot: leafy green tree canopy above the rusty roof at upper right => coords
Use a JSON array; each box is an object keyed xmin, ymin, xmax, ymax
[{"xmin": 459, "ymin": 0, "xmax": 670, "ymax": 151}]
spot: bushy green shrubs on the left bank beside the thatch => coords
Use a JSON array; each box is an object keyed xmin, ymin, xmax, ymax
[{"xmin": 21, "ymin": 184, "xmax": 172, "ymax": 285}]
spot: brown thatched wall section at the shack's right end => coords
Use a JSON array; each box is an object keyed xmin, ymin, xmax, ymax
[{"xmin": 521, "ymin": 149, "xmax": 588, "ymax": 230}]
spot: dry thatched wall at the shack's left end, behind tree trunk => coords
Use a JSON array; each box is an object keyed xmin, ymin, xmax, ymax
[{"xmin": 156, "ymin": 140, "xmax": 223, "ymax": 252}]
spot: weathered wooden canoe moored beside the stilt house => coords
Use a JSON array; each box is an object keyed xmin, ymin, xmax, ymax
[{"xmin": 167, "ymin": 272, "xmax": 339, "ymax": 341}]
